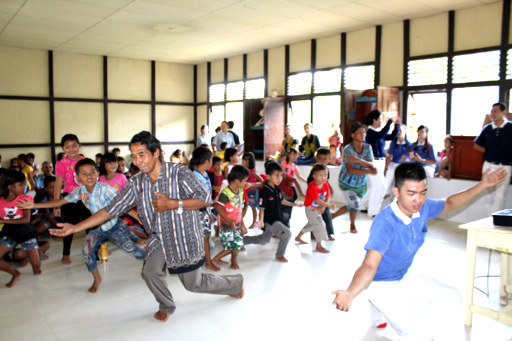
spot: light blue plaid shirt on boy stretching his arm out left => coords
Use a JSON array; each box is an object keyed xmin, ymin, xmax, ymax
[{"xmin": 64, "ymin": 182, "xmax": 118, "ymax": 232}]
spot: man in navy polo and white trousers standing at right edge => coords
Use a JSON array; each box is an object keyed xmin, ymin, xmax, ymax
[{"xmin": 473, "ymin": 103, "xmax": 512, "ymax": 215}]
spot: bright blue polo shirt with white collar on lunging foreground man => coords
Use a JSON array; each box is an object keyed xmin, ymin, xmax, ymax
[{"xmin": 364, "ymin": 198, "xmax": 445, "ymax": 281}]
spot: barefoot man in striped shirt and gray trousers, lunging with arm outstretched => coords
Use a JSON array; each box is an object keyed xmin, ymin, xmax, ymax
[{"xmin": 51, "ymin": 131, "xmax": 244, "ymax": 322}]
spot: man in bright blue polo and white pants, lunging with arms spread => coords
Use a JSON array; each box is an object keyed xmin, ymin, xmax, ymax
[{"xmin": 333, "ymin": 163, "xmax": 505, "ymax": 341}]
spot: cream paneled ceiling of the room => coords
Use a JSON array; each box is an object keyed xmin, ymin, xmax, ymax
[{"xmin": 0, "ymin": 0, "xmax": 499, "ymax": 64}]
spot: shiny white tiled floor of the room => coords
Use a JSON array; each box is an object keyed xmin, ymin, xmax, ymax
[{"xmin": 0, "ymin": 208, "xmax": 512, "ymax": 341}]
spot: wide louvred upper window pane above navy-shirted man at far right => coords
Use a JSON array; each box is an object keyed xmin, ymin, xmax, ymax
[{"xmin": 452, "ymin": 51, "xmax": 500, "ymax": 83}]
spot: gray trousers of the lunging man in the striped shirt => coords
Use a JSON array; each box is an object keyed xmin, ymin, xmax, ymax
[{"xmin": 141, "ymin": 248, "xmax": 244, "ymax": 314}]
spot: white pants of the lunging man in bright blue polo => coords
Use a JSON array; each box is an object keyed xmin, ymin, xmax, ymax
[{"xmin": 367, "ymin": 275, "xmax": 461, "ymax": 341}]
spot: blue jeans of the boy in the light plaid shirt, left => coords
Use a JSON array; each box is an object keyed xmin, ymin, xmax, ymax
[{"xmin": 82, "ymin": 219, "xmax": 146, "ymax": 272}]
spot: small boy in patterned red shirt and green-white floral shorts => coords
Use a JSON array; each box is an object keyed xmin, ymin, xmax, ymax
[{"xmin": 212, "ymin": 165, "xmax": 249, "ymax": 269}]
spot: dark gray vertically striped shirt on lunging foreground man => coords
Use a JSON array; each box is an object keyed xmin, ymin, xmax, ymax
[{"xmin": 105, "ymin": 162, "xmax": 211, "ymax": 273}]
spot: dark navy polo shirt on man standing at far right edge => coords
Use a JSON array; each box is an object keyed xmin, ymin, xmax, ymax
[{"xmin": 473, "ymin": 120, "xmax": 512, "ymax": 165}]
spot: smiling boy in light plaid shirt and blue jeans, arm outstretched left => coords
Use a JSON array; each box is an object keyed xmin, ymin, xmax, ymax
[{"xmin": 18, "ymin": 159, "xmax": 146, "ymax": 293}]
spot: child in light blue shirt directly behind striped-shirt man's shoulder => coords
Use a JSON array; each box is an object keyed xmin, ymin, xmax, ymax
[{"xmin": 190, "ymin": 147, "xmax": 220, "ymax": 271}]
